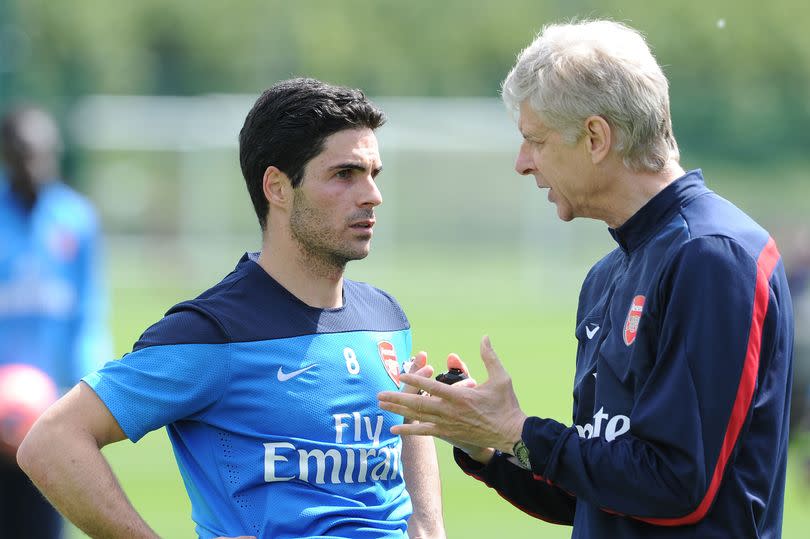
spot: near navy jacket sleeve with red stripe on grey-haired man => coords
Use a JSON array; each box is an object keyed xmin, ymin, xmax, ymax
[{"xmin": 523, "ymin": 237, "xmax": 779, "ymax": 526}]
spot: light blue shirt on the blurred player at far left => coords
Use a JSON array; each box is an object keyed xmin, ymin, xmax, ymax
[{"xmin": 0, "ymin": 177, "xmax": 110, "ymax": 390}]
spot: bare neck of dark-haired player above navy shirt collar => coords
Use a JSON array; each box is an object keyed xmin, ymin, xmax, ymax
[{"xmin": 258, "ymin": 231, "xmax": 344, "ymax": 309}]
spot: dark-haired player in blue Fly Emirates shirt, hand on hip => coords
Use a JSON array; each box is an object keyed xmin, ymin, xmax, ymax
[{"xmin": 18, "ymin": 79, "xmax": 444, "ymax": 538}]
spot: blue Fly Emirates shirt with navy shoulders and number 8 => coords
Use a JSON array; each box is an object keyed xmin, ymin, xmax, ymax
[{"xmin": 84, "ymin": 254, "xmax": 412, "ymax": 539}]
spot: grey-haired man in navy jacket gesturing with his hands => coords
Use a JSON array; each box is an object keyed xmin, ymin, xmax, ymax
[{"xmin": 380, "ymin": 17, "xmax": 793, "ymax": 538}]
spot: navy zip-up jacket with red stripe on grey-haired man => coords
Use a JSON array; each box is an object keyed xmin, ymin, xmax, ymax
[{"xmin": 456, "ymin": 171, "xmax": 793, "ymax": 539}]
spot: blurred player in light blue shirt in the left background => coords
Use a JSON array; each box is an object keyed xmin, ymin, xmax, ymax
[{"xmin": 0, "ymin": 106, "xmax": 109, "ymax": 538}]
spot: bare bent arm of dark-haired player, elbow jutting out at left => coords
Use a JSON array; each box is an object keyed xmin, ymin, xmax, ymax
[{"xmin": 17, "ymin": 382, "xmax": 158, "ymax": 538}]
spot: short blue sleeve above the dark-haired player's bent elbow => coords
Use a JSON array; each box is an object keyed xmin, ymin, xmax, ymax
[{"xmin": 83, "ymin": 311, "xmax": 231, "ymax": 442}]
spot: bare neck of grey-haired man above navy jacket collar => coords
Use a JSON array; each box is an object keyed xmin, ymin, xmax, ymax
[{"xmin": 599, "ymin": 161, "xmax": 684, "ymax": 228}]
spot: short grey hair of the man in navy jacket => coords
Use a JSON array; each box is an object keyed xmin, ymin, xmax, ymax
[{"xmin": 501, "ymin": 20, "xmax": 680, "ymax": 172}]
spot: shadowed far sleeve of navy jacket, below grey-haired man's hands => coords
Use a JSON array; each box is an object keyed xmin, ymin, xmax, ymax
[{"xmin": 453, "ymin": 448, "xmax": 577, "ymax": 525}]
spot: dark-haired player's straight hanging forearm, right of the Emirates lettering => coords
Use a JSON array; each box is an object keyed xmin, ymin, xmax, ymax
[{"xmin": 402, "ymin": 436, "xmax": 445, "ymax": 539}]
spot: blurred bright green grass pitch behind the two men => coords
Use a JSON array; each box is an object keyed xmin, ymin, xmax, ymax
[{"xmin": 66, "ymin": 243, "xmax": 810, "ymax": 539}]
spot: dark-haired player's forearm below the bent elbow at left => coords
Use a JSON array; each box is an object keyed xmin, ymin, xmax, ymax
[{"xmin": 17, "ymin": 417, "xmax": 158, "ymax": 539}]
